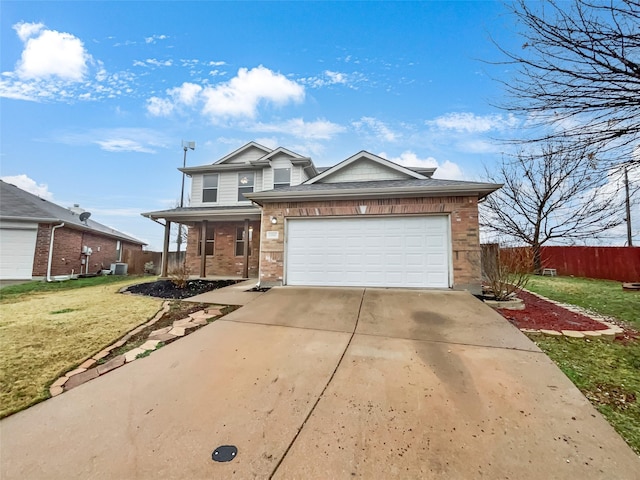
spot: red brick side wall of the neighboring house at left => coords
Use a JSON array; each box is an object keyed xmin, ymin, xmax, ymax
[{"xmin": 33, "ymin": 223, "xmax": 142, "ymax": 277}]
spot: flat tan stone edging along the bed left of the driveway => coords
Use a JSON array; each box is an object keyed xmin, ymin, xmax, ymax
[{"xmin": 49, "ymin": 300, "xmax": 222, "ymax": 397}]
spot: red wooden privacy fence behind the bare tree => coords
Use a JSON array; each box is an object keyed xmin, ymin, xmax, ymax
[{"xmin": 503, "ymin": 247, "xmax": 640, "ymax": 282}]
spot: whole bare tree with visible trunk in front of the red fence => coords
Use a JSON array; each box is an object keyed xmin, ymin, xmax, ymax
[{"xmin": 480, "ymin": 144, "xmax": 624, "ymax": 273}]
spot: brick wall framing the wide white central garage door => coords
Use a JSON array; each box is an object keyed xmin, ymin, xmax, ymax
[{"xmin": 260, "ymin": 197, "xmax": 481, "ymax": 292}]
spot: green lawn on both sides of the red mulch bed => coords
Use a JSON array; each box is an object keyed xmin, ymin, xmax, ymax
[{"xmin": 527, "ymin": 277, "xmax": 640, "ymax": 454}]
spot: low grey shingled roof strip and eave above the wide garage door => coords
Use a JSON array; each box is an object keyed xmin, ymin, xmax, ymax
[{"xmin": 245, "ymin": 178, "xmax": 502, "ymax": 204}]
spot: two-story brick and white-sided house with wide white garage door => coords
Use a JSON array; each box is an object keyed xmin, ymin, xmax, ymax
[{"xmin": 143, "ymin": 142, "xmax": 501, "ymax": 293}]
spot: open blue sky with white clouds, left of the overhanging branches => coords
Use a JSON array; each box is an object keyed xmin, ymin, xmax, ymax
[{"xmin": 0, "ymin": 1, "xmax": 632, "ymax": 250}]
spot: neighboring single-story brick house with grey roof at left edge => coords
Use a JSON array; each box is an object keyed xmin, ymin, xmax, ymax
[{"xmin": 0, "ymin": 181, "xmax": 145, "ymax": 280}]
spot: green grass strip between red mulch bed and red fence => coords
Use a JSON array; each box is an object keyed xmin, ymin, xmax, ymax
[{"xmin": 526, "ymin": 275, "xmax": 640, "ymax": 329}]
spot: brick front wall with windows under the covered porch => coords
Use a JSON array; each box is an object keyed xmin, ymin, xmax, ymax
[{"xmin": 185, "ymin": 221, "xmax": 260, "ymax": 278}]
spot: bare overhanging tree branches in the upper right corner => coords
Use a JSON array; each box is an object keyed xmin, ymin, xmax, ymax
[{"xmin": 499, "ymin": 0, "xmax": 640, "ymax": 166}]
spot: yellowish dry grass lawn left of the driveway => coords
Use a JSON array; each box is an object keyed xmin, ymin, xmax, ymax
[{"xmin": 0, "ymin": 277, "xmax": 162, "ymax": 418}]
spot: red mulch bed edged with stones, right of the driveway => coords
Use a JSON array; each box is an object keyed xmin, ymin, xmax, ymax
[{"xmin": 498, "ymin": 292, "xmax": 607, "ymax": 331}]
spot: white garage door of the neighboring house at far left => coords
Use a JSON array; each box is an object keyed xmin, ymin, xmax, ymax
[{"xmin": 0, "ymin": 228, "xmax": 38, "ymax": 280}]
